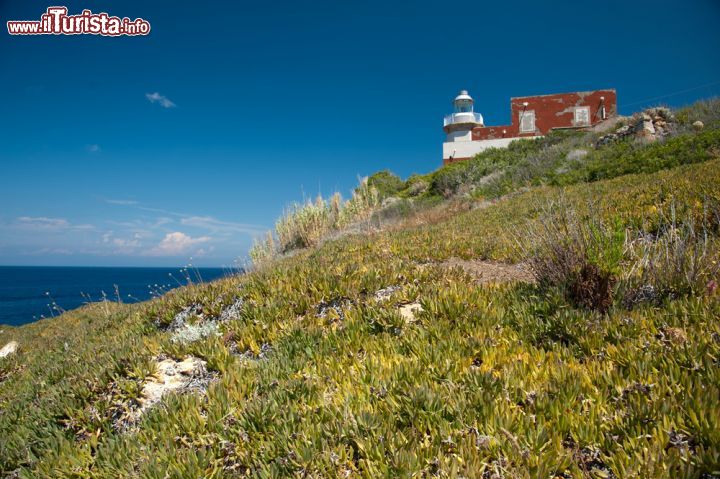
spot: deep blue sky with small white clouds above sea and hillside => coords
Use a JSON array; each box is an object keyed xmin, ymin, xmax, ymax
[{"xmin": 0, "ymin": 0, "xmax": 720, "ymax": 266}]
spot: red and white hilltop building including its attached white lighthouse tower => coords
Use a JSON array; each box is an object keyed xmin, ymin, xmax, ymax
[{"xmin": 443, "ymin": 89, "xmax": 617, "ymax": 163}]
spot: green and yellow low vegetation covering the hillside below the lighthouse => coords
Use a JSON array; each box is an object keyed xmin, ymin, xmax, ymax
[{"xmin": 0, "ymin": 99, "xmax": 720, "ymax": 479}]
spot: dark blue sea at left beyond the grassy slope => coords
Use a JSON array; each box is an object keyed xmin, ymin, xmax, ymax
[{"xmin": 0, "ymin": 266, "xmax": 230, "ymax": 326}]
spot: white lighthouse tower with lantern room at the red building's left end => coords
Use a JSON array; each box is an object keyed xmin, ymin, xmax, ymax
[{"xmin": 443, "ymin": 90, "xmax": 484, "ymax": 163}]
